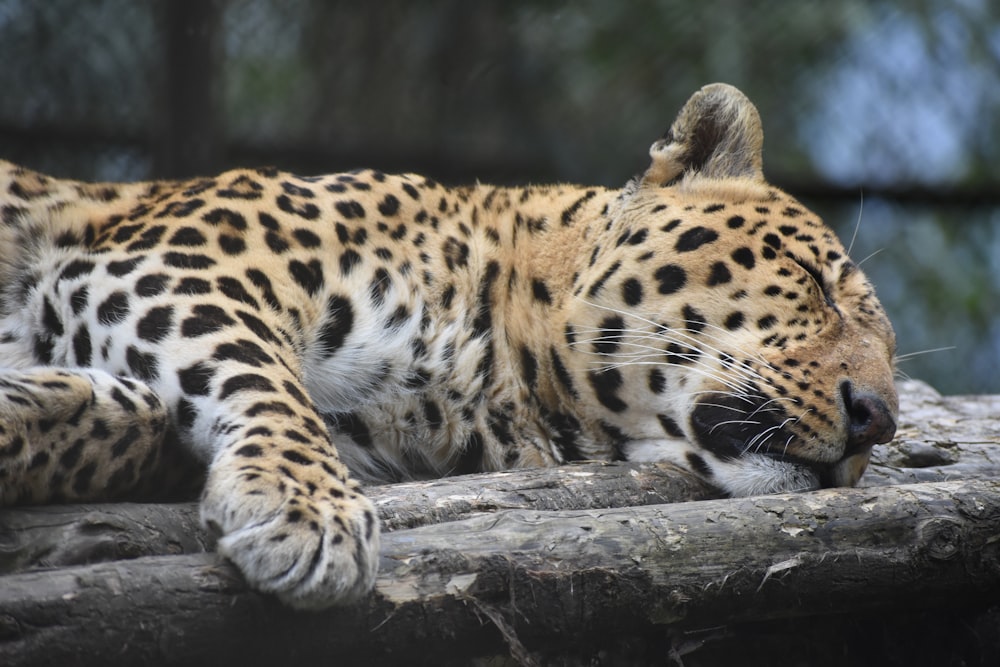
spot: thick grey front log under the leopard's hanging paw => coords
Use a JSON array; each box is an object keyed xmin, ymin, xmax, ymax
[{"xmin": 0, "ymin": 481, "xmax": 1000, "ymax": 667}]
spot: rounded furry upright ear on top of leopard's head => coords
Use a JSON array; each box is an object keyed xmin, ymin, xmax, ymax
[{"xmin": 642, "ymin": 83, "xmax": 764, "ymax": 186}]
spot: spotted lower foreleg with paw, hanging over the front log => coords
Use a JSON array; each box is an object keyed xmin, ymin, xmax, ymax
[{"xmin": 186, "ymin": 360, "xmax": 378, "ymax": 608}]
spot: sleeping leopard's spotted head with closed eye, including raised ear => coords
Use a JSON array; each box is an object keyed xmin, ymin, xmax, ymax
[{"xmin": 566, "ymin": 84, "xmax": 898, "ymax": 495}]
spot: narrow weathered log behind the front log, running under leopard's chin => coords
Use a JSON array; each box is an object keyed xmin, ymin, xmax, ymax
[{"xmin": 0, "ymin": 462, "xmax": 720, "ymax": 575}]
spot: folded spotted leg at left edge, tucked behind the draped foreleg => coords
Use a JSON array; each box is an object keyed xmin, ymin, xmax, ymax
[{"xmin": 0, "ymin": 366, "xmax": 168, "ymax": 505}]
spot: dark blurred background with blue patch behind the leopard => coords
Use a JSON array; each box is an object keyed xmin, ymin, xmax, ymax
[{"xmin": 0, "ymin": 0, "xmax": 1000, "ymax": 393}]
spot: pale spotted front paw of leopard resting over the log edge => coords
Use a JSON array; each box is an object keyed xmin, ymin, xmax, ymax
[{"xmin": 201, "ymin": 466, "xmax": 379, "ymax": 609}]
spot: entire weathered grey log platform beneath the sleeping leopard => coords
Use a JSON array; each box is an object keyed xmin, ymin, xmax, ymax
[{"xmin": 0, "ymin": 383, "xmax": 1000, "ymax": 665}]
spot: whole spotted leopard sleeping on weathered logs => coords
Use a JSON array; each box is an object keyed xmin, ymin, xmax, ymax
[{"xmin": 0, "ymin": 84, "xmax": 898, "ymax": 609}]
